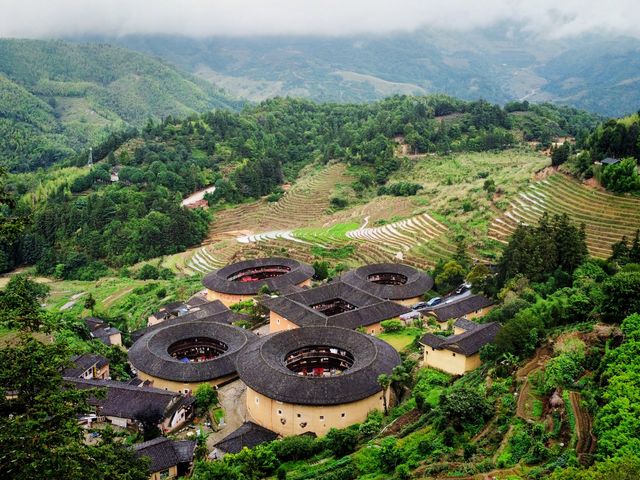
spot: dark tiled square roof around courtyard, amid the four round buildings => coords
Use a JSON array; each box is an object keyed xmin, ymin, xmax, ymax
[{"xmin": 260, "ymin": 282, "xmax": 411, "ymax": 328}]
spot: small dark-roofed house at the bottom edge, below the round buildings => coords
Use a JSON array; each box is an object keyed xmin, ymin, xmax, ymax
[{"xmin": 133, "ymin": 437, "xmax": 196, "ymax": 480}]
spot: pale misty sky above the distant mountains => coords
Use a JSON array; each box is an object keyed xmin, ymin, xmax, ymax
[{"xmin": 0, "ymin": 0, "xmax": 640, "ymax": 38}]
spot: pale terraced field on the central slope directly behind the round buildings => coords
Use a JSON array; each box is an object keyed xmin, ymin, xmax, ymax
[{"xmin": 162, "ymin": 150, "xmax": 548, "ymax": 275}]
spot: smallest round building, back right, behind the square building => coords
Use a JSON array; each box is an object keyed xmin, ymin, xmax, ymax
[{"xmin": 340, "ymin": 263, "xmax": 433, "ymax": 306}]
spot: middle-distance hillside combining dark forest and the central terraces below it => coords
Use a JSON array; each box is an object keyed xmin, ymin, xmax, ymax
[{"xmin": 0, "ymin": 96, "xmax": 597, "ymax": 279}]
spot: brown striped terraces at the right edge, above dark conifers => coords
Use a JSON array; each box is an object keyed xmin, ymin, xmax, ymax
[{"xmin": 489, "ymin": 174, "xmax": 640, "ymax": 258}]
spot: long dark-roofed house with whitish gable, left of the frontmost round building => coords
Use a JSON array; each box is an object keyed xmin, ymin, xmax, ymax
[{"xmin": 64, "ymin": 377, "xmax": 195, "ymax": 433}]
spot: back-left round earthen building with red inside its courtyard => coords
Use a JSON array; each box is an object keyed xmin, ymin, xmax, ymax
[{"xmin": 202, "ymin": 257, "xmax": 314, "ymax": 306}]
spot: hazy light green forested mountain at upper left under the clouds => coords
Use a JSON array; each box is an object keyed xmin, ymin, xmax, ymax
[{"xmin": 0, "ymin": 39, "xmax": 239, "ymax": 170}]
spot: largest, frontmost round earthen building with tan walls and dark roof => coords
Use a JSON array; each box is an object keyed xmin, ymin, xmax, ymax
[{"xmin": 237, "ymin": 326, "xmax": 400, "ymax": 436}]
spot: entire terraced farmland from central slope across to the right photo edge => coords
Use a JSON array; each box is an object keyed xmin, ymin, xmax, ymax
[{"xmin": 162, "ymin": 150, "xmax": 640, "ymax": 275}]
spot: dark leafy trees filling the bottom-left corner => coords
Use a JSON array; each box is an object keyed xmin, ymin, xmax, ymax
[{"xmin": 0, "ymin": 337, "xmax": 149, "ymax": 480}]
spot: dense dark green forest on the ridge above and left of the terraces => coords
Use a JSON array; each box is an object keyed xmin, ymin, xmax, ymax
[{"xmin": 2, "ymin": 96, "xmax": 597, "ymax": 279}]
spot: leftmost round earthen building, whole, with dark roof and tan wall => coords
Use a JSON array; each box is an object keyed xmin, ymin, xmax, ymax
[{"xmin": 129, "ymin": 319, "xmax": 257, "ymax": 393}]
